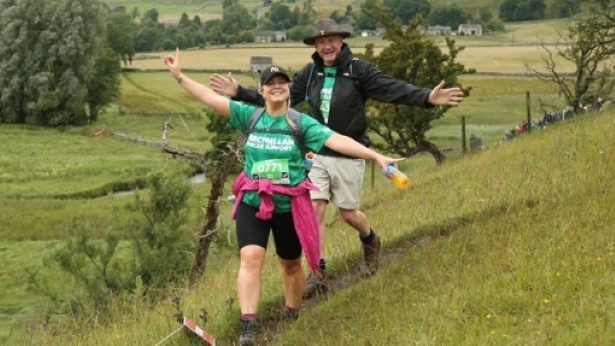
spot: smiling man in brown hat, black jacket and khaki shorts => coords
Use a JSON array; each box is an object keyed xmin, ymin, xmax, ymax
[{"xmin": 210, "ymin": 19, "xmax": 464, "ymax": 297}]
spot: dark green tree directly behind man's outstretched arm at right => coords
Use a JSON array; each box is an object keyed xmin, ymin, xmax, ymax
[{"xmin": 358, "ymin": 10, "xmax": 469, "ymax": 163}]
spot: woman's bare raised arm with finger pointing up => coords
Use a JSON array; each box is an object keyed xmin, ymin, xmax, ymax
[{"xmin": 164, "ymin": 48, "xmax": 231, "ymax": 118}]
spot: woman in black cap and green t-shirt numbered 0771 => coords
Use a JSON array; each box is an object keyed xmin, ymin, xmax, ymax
[{"xmin": 164, "ymin": 50, "xmax": 404, "ymax": 345}]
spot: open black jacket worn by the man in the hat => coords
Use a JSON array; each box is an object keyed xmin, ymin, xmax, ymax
[{"xmin": 234, "ymin": 43, "xmax": 431, "ymax": 156}]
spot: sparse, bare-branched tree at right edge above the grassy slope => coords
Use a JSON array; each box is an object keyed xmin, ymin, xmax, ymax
[{"xmin": 526, "ymin": 0, "xmax": 615, "ymax": 104}]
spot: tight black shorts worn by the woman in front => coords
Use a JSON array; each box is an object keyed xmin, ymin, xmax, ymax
[{"xmin": 236, "ymin": 202, "xmax": 301, "ymax": 260}]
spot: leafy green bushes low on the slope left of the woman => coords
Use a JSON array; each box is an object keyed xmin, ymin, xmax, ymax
[{"xmin": 29, "ymin": 171, "xmax": 195, "ymax": 323}]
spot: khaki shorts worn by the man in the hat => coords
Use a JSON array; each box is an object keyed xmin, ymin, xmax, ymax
[{"xmin": 309, "ymin": 155, "xmax": 365, "ymax": 210}]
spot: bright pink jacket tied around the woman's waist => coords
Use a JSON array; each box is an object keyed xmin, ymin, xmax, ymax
[{"xmin": 232, "ymin": 172, "xmax": 320, "ymax": 273}]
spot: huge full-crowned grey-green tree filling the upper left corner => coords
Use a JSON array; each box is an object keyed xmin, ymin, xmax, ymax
[{"xmin": 0, "ymin": 0, "xmax": 118, "ymax": 126}]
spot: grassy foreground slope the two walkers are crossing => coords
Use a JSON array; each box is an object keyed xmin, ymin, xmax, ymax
[{"xmin": 6, "ymin": 104, "xmax": 615, "ymax": 345}]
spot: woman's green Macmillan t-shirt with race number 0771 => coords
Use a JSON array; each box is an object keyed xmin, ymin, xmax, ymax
[{"xmin": 229, "ymin": 101, "xmax": 334, "ymax": 213}]
